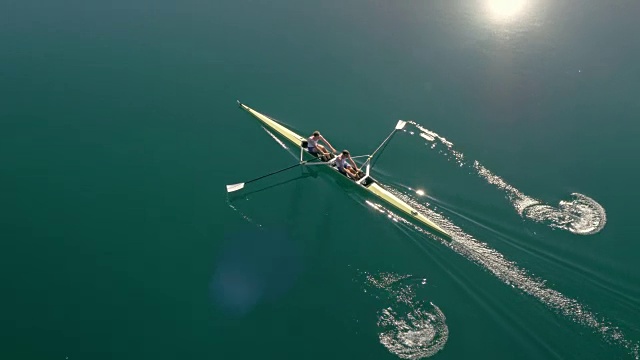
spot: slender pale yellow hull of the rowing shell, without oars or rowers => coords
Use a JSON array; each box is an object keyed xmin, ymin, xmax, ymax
[{"xmin": 238, "ymin": 101, "xmax": 451, "ymax": 238}]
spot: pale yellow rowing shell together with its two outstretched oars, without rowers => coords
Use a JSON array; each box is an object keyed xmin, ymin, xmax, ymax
[{"xmin": 227, "ymin": 101, "xmax": 451, "ymax": 239}]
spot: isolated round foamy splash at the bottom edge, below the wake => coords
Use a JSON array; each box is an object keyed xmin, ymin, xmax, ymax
[{"xmin": 360, "ymin": 272, "xmax": 449, "ymax": 360}]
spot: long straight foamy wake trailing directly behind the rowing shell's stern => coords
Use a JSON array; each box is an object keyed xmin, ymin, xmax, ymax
[{"xmin": 365, "ymin": 193, "xmax": 640, "ymax": 360}]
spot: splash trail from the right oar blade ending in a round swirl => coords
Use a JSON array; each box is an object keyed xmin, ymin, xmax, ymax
[{"xmin": 405, "ymin": 121, "xmax": 607, "ymax": 235}]
